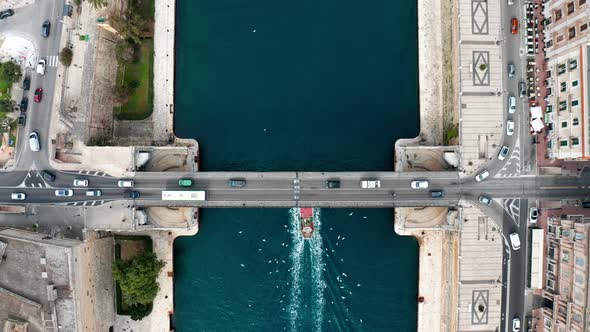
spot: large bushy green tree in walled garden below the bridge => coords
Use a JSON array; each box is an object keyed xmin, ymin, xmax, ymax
[{"xmin": 113, "ymin": 253, "xmax": 164, "ymax": 305}]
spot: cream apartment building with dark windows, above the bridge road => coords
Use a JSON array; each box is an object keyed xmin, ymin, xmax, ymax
[{"xmin": 544, "ymin": 0, "xmax": 590, "ymax": 160}]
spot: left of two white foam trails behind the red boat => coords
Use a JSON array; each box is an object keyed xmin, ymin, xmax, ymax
[{"xmin": 287, "ymin": 208, "xmax": 305, "ymax": 332}]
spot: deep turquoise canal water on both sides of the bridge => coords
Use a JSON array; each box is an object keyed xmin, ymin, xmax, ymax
[{"xmin": 173, "ymin": 0, "xmax": 418, "ymax": 331}]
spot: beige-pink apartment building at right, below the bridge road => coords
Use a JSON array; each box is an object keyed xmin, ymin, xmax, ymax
[{"xmin": 533, "ymin": 216, "xmax": 590, "ymax": 332}]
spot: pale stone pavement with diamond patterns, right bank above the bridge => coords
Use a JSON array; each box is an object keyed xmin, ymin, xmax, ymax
[{"xmin": 458, "ymin": 0, "xmax": 507, "ymax": 173}]
